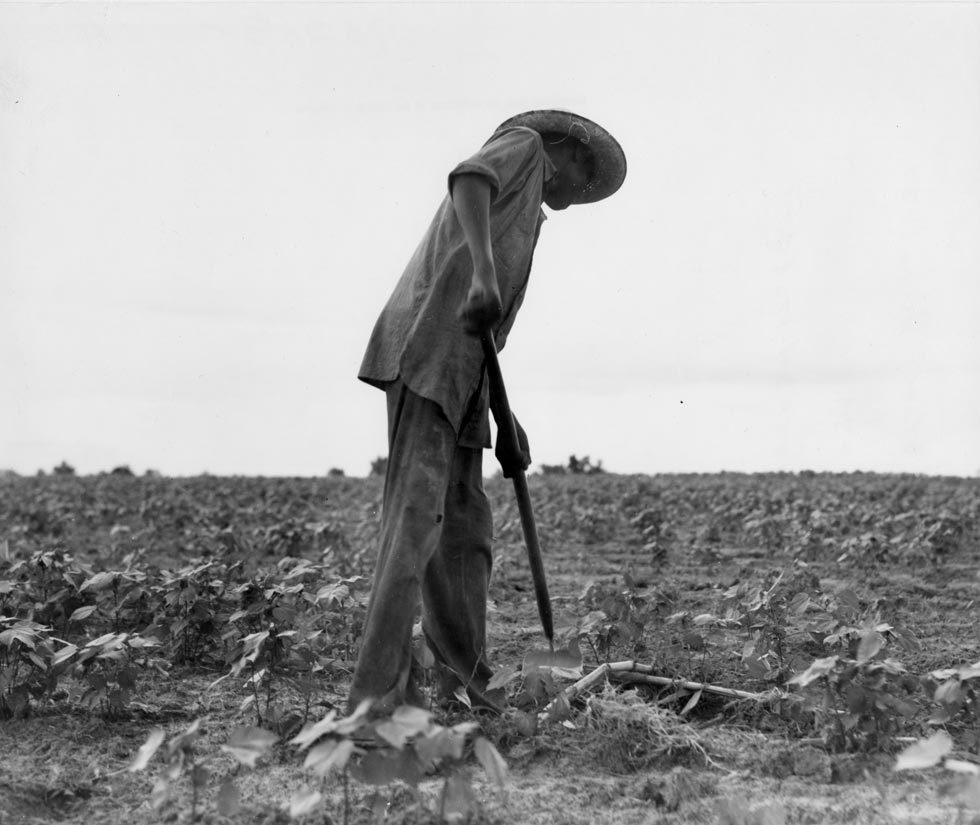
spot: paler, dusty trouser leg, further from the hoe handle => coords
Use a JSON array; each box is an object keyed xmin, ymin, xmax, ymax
[{"xmin": 349, "ymin": 381, "xmax": 456, "ymax": 709}]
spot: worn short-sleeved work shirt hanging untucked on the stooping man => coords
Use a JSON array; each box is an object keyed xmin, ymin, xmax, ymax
[{"xmin": 358, "ymin": 127, "xmax": 555, "ymax": 447}]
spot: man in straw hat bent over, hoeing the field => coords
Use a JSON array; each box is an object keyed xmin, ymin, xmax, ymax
[{"xmin": 349, "ymin": 110, "xmax": 626, "ymax": 711}]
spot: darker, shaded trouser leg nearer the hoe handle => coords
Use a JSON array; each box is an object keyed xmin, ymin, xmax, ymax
[{"xmin": 422, "ymin": 447, "xmax": 494, "ymax": 707}]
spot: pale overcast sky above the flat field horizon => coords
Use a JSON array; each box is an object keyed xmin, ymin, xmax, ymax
[{"xmin": 0, "ymin": 2, "xmax": 980, "ymax": 475}]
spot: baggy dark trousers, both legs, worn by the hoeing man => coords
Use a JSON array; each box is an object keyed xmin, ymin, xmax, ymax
[{"xmin": 349, "ymin": 380, "xmax": 493, "ymax": 710}]
